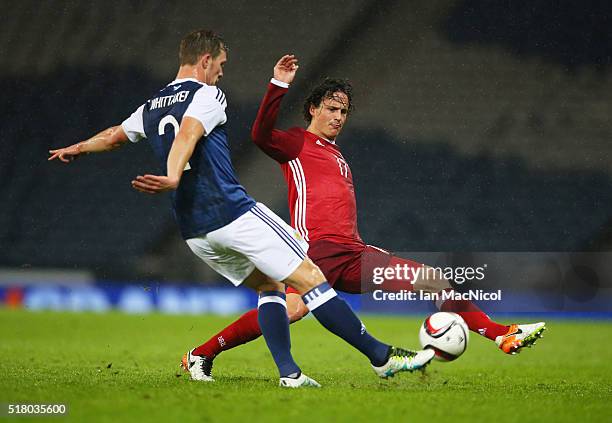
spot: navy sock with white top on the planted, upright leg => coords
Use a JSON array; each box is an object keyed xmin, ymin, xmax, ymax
[{"xmin": 257, "ymin": 291, "xmax": 300, "ymax": 377}]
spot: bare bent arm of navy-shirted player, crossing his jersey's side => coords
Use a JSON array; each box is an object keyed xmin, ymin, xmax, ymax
[{"xmin": 132, "ymin": 116, "xmax": 204, "ymax": 194}]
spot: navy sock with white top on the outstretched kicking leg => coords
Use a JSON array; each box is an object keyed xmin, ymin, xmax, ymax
[{"xmin": 302, "ymin": 282, "xmax": 390, "ymax": 367}]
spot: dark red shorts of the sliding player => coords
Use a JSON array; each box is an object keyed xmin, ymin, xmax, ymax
[{"xmin": 286, "ymin": 240, "xmax": 421, "ymax": 294}]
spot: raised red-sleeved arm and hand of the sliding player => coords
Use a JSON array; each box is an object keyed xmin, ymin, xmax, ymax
[{"xmin": 251, "ymin": 54, "xmax": 304, "ymax": 163}]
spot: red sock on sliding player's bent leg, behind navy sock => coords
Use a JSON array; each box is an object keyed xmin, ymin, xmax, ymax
[{"xmin": 193, "ymin": 309, "xmax": 261, "ymax": 358}]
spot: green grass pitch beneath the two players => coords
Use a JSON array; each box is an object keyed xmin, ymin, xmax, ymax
[{"xmin": 0, "ymin": 309, "xmax": 612, "ymax": 423}]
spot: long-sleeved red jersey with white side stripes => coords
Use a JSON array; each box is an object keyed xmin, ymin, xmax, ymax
[{"xmin": 251, "ymin": 83, "xmax": 364, "ymax": 246}]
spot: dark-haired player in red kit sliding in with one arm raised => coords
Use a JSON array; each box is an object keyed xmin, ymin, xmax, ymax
[{"xmin": 193, "ymin": 55, "xmax": 545, "ymax": 378}]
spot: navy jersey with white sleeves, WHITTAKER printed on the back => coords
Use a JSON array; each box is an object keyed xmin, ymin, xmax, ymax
[{"xmin": 122, "ymin": 78, "xmax": 255, "ymax": 239}]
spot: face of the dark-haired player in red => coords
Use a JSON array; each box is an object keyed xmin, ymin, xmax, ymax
[{"xmin": 309, "ymin": 92, "xmax": 349, "ymax": 141}]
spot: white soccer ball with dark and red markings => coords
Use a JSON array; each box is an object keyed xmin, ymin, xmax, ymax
[{"xmin": 419, "ymin": 312, "xmax": 470, "ymax": 361}]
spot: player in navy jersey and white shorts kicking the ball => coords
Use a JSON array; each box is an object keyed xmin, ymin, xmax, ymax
[{"xmin": 49, "ymin": 30, "xmax": 434, "ymax": 388}]
